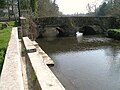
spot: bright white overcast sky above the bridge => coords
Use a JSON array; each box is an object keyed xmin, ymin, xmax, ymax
[{"xmin": 56, "ymin": 0, "xmax": 103, "ymax": 14}]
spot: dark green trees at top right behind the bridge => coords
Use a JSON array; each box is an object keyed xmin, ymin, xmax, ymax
[{"xmin": 97, "ymin": 0, "xmax": 120, "ymax": 17}]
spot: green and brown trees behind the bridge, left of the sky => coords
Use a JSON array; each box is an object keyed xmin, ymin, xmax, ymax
[{"xmin": 20, "ymin": 0, "xmax": 58, "ymax": 17}]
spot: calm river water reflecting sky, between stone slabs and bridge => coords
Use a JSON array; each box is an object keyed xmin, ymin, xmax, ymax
[{"xmin": 37, "ymin": 35, "xmax": 120, "ymax": 90}]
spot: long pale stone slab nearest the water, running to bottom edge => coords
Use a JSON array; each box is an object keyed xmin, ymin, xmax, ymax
[{"xmin": 28, "ymin": 52, "xmax": 65, "ymax": 90}]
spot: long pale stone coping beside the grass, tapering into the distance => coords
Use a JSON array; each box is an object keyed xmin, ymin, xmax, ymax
[{"xmin": 0, "ymin": 27, "xmax": 24, "ymax": 90}]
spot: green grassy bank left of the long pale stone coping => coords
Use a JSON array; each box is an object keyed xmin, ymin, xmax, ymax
[{"xmin": 0, "ymin": 21, "xmax": 15, "ymax": 73}]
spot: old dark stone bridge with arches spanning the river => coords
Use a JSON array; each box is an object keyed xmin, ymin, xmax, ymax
[{"xmin": 35, "ymin": 17, "xmax": 116, "ymax": 36}]
